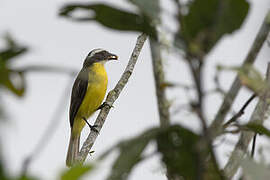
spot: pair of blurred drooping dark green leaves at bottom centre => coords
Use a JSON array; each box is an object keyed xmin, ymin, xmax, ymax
[{"xmin": 102, "ymin": 125, "xmax": 220, "ymax": 180}]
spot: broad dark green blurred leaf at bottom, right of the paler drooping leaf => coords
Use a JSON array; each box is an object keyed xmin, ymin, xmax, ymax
[{"xmin": 157, "ymin": 126, "xmax": 199, "ymax": 179}]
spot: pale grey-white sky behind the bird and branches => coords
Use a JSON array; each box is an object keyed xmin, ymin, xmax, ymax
[{"xmin": 0, "ymin": 0, "xmax": 270, "ymax": 180}]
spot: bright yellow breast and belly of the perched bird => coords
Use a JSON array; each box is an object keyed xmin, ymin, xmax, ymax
[{"xmin": 72, "ymin": 63, "xmax": 108, "ymax": 134}]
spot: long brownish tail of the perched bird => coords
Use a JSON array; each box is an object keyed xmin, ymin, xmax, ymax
[{"xmin": 66, "ymin": 133, "xmax": 80, "ymax": 167}]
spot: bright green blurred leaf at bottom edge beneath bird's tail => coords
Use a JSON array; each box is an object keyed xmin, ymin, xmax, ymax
[{"xmin": 61, "ymin": 164, "xmax": 93, "ymax": 180}]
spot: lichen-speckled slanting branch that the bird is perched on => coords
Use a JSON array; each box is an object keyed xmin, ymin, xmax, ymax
[{"xmin": 76, "ymin": 34, "xmax": 147, "ymax": 163}]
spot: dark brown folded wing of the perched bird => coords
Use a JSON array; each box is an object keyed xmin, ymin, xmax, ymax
[{"xmin": 69, "ymin": 69, "xmax": 88, "ymax": 127}]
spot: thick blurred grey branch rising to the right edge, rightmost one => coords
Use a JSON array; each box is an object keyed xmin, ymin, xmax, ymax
[{"xmin": 224, "ymin": 62, "xmax": 270, "ymax": 179}]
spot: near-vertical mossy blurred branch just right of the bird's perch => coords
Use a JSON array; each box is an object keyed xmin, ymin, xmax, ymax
[{"xmin": 150, "ymin": 39, "xmax": 170, "ymax": 127}]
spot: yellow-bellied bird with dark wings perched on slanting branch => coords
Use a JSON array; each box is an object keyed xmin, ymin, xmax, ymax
[{"xmin": 66, "ymin": 48, "xmax": 118, "ymax": 167}]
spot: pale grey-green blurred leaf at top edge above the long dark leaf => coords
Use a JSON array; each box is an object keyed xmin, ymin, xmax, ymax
[{"xmin": 128, "ymin": 0, "xmax": 161, "ymax": 22}]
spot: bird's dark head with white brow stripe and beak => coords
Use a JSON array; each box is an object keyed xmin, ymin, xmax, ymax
[{"xmin": 83, "ymin": 49, "xmax": 118, "ymax": 67}]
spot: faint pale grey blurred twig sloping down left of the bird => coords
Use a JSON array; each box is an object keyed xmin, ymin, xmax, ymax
[{"xmin": 21, "ymin": 78, "xmax": 74, "ymax": 175}]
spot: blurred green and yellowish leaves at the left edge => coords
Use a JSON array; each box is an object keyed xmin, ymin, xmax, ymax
[{"xmin": 0, "ymin": 35, "xmax": 27, "ymax": 97}]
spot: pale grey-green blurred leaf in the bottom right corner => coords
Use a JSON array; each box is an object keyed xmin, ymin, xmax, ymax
[{"xmin": 241, "ymin": 158, "xmax": 270, "ymax": 180}]
